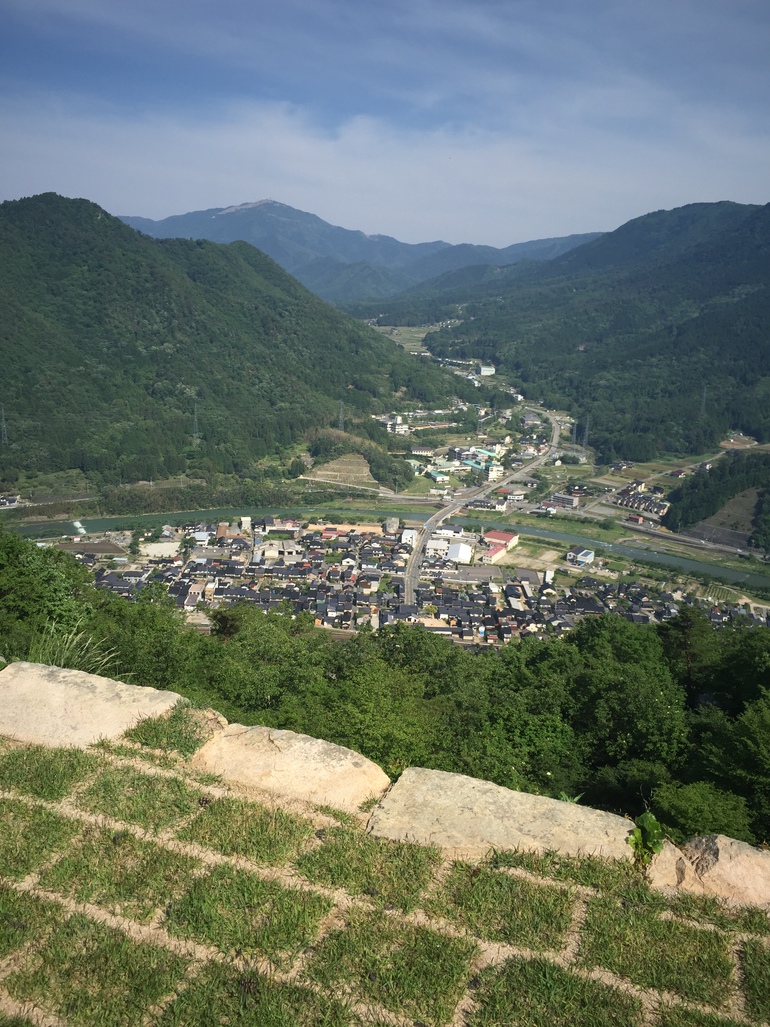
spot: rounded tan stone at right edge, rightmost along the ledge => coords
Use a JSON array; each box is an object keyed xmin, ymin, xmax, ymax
[{"xmin": 682, "ymin": 835, "xmax": 770, "ymax": 909}]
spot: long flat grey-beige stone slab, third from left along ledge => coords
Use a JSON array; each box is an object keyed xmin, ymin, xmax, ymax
[{"xmin": 370, "ymin": 767, "xmax": 633, "ymax": 860}]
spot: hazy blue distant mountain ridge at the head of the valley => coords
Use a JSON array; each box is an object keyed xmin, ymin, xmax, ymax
[{"xmin": 121, "ymin": 199, "xmax": 598, "ymax": 303}]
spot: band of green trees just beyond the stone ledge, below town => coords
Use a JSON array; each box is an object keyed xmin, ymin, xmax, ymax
[{"xmin": 0, "ymin": 530, "xmax": 770, "ymax": 841}]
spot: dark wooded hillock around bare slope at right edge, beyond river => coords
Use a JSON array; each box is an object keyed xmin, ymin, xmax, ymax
[{"xmin": 663, "ymin": 453, "xmax": 770, "ymax": 554}]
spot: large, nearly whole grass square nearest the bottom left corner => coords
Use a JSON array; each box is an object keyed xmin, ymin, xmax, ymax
[{"xmin": 5, "ymin": 915, "xmax": 186, "ymax": 1027}]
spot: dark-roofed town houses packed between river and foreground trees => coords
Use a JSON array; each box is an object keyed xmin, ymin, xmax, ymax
[{"xmin": 87, "ymin": 518, "xmax": 764, "ymax": 645}]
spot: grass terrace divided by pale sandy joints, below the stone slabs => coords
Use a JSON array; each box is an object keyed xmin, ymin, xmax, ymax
[{"xmin": 0, "ymin": 711, "xmax": 770, "ymax": 1027}]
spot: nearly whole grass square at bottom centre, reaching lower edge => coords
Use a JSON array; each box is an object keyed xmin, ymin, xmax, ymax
[{"xmin": 307, "ymin": 910, "xmax": 476, "ymax": 1025}]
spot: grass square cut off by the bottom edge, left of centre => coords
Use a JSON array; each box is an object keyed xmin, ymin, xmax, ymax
[{"xmin": 158, "ymin": 962, "xmax": 350, "ymax": 1027}]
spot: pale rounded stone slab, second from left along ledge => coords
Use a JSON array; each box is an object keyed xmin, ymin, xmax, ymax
[{"xmin": 190, "ymin": 724, "xmax": 390, "ymax": 812}]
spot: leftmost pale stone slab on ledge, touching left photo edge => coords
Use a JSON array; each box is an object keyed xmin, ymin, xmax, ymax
[{"xmin": 0, "ymin": 662, "xmax": 181, "ymax": 748}]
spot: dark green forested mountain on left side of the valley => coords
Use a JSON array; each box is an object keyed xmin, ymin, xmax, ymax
[{"xmin": 0, "ymin": 193, "xmax": 455, "ymax": 484}]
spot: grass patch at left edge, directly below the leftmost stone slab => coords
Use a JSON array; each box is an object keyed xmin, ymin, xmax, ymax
[{"xmin": 0, "ymin": 746, "xmax": 101, "ymax": 802}]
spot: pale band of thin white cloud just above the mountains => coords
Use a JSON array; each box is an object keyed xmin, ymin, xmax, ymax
[{"xmin": 0, "ymin": 88, "xmax": 770, "ymax": 245}]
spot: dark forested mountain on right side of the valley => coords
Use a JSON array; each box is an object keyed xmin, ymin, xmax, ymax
[{"xmin": 416, "ymin": 203, "xmax": 770, "ymax": 460}]
